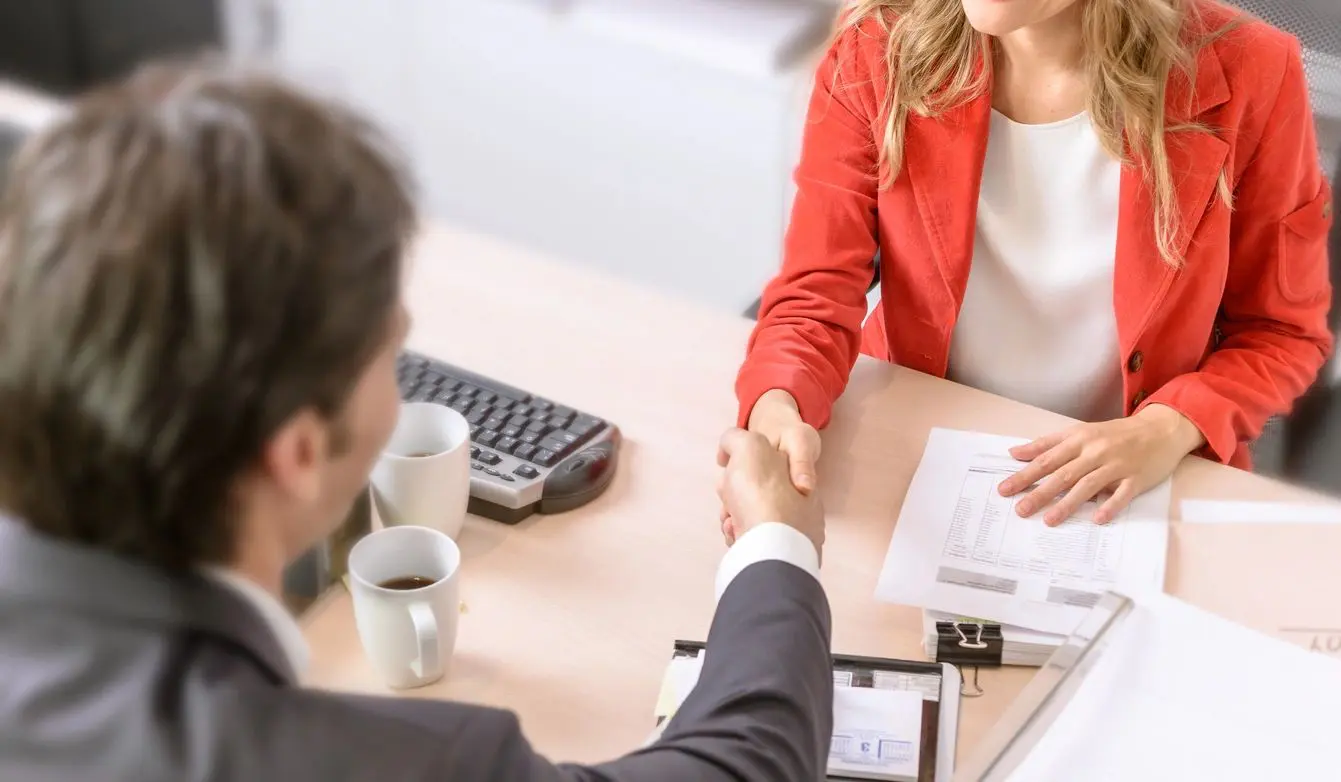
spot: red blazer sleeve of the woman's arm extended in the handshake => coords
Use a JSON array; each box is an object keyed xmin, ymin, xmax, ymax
[{"xmin": 736, "ymin": 25, "xmax": 880, "ymax": 428}]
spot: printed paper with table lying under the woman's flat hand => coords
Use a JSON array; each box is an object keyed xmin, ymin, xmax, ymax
[{"xmin": 876, "ymin": 429, "xmax": 1171, "ymax": 634}]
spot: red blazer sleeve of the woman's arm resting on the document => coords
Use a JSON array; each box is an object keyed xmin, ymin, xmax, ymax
[{"xmin": 1143, "ymin": 39, "xmax": 1333, "ymax": 461}]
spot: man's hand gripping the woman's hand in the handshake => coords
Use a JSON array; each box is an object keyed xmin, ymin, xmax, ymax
[{"xmin": 717, "ymin": 429, "xmax": 825, "ymax": 551}]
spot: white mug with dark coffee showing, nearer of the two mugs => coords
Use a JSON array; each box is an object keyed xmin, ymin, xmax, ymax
[{"xmin": 349, "ymin": 526, "xmax": 461, "ymax": 689}]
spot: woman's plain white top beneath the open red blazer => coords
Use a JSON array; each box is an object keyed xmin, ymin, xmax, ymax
[{"xmin": 949, "ymin": 111, "xmax": 1122, "ymax": 421}]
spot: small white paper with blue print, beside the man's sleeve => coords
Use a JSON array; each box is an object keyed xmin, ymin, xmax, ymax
[{"xmin": 829, "ymin": 687, "xmax": 923, "ymax": 781}]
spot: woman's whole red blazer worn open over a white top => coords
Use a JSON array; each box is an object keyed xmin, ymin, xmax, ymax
[{"xmin": 736, "ymin": 3, "xmax": 1333, "ymax": 467}]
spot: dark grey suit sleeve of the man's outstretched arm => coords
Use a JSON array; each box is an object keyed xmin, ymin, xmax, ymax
[{"xmin": 477, "ymin": 561, "xmax": 833, "ymax": 782}]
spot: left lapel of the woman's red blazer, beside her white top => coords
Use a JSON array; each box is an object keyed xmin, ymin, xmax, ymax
[{"xmin": 904, "ymin": 90, "xmax": 992, "ymax": 313}]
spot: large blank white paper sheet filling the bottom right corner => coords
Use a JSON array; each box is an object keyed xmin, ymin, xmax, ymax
[{"xmin": 1008, "ymin": 593, "xmax": 1341, "ymax": 782}]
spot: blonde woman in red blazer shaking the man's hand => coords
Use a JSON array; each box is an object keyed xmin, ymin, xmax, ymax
[{"xmin": 727, "ymin": 0, "xmax": 1332, "ymax": 528}]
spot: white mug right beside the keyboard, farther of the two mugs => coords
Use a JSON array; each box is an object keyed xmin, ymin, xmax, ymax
[{"xmin": 373, "ymin": 402, "xmax": 471, "ymax": 538}]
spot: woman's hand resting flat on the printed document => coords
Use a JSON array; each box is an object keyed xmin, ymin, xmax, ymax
[{"xmin": 1000, "ymin": 405, "xmax": 1206, "ymax": 527}]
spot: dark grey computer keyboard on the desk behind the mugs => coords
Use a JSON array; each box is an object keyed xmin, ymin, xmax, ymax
[{"xmin": 397, "ymin": 351, "xmax": 621, "ymax": 524}]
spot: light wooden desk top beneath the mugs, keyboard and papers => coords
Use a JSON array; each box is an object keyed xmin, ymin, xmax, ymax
[{"xmin": 304, "ymin": 227, "xmax": 1309, "ymax": 762}]
